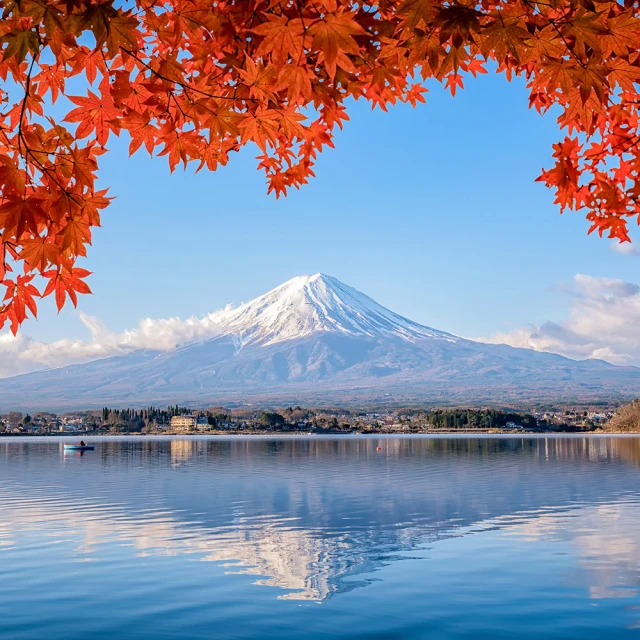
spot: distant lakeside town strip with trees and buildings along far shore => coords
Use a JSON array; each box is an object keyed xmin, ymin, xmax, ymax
[{"xmin": 0, "ymin": 405, "xmax": 614, "ymax": 436}]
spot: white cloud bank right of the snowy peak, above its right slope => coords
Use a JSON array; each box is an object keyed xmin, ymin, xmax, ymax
[{"xmin": 481, "ymin": 274, "xmax": 640, "ymax": 365}]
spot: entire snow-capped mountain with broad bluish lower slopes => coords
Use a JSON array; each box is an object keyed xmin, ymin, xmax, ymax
[{"xmin": 0, "ymin": 274, "xmax": 640, "ymax": 408}]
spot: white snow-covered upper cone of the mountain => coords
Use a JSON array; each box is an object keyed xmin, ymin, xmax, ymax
[{"xmin": 208, "ymin": 273, "xmax": 455, "ymax": 345}]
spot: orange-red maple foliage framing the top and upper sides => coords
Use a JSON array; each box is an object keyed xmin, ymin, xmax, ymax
[{"xmin": 0, "ymin": 0, "xmax": 640, "ymax": 333}]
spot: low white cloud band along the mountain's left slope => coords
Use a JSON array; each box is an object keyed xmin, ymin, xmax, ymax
[{"xmin": 0, "ymin": 309, "xmax": 228, "ymax": 378}]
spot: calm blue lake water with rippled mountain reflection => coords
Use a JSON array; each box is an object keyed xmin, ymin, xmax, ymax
[{"xmin": 0, "ymin": 437, "xmax": 640, "ymax": 640}]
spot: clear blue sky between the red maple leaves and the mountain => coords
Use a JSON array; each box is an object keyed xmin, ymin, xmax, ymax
[{"xmin": 5, "ymin": 68, "xmax": 640, "ymax": 368}]
